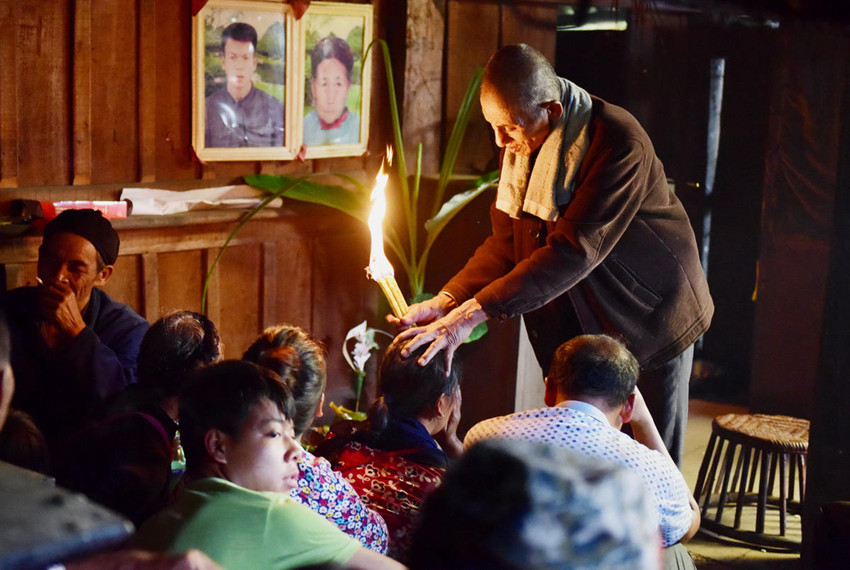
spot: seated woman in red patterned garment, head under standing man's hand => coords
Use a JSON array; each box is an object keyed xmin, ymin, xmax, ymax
[{"xmin": 316, "ymin": 342, "xmax": 462, "ymax": 560}]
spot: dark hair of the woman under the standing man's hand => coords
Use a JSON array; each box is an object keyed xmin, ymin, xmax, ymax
[{"xmin": 369, "ymin": 342, "xmax": 460, "ymax": 431}]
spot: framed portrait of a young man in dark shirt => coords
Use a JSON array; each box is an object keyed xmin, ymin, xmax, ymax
[{"xmin": 192, "ymin": 0, "xmax": 301, "ymax": 162}]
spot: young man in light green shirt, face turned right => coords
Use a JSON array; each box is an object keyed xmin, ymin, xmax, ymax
[{"xmin": 132, "ymin": 360, "xmax": 403, "ymax": 570}]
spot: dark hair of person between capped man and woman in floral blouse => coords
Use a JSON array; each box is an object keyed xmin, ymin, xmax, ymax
[{"xmin": 137, "ymin": 311, "xmax": 221, "ymax": 399}]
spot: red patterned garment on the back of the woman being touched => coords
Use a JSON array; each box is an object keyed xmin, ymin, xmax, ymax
[{"xmin": 334, "ymin": 441, "xmax": 446, "ymax": 560}]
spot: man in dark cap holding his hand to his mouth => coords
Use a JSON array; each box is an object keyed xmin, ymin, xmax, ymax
[{"xmin": 2, "ymin": 210, "xmax": 149, "ymax": 443}]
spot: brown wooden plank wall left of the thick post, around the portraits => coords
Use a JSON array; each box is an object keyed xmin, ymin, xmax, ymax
[{"xmin": 0, "ymin": 0, "xmax": 394, "ymax": 414}]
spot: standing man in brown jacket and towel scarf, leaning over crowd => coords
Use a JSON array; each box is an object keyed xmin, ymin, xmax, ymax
[{"xmin": 389, "ymin": 44, "xmax": 714, "ymax": 463}]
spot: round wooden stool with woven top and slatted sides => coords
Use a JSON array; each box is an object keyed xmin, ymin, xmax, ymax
[{"xmin": 694, "ymin": 414, "xmax": 809, "ymax": 551}]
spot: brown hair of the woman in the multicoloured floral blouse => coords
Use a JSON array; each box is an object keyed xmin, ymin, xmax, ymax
[{"xmin": 242, "ymin": 325, "xmax": 328, "ymax": 436}]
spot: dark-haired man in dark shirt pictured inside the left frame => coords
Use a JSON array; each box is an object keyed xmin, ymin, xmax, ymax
[{"xmin": 205, "ymin": 22, "xmax": 283, "ymax": 148}]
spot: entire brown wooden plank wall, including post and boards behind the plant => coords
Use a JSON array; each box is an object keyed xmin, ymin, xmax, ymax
[{"xmin": 0, "ymin": 0, "xmax": 544, "ymax": 425}]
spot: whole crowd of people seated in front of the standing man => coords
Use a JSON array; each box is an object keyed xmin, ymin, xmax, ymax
[{"xmin": 0, "ymin": 211, "xmax": 699, "ymax": 569}]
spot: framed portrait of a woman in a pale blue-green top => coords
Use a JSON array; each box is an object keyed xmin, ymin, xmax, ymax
[{"xmin": 299, "ymin": 2, "xmax": 372, "ymax": 158}]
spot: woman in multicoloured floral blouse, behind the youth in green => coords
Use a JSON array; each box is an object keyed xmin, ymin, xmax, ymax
[{"xmin": 242, "ymin": 325, "xmax": 387, "ymax": 554}]
